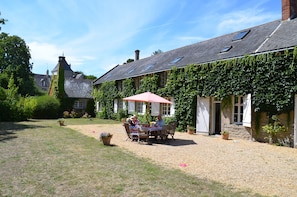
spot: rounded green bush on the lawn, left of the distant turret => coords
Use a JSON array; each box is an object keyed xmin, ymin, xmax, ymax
[{"xmin": 32, "ymin": 96, "xmax": 60, "ymax": 118}]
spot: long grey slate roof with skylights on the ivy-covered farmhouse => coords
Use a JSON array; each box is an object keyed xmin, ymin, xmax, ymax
[{"xmin": 94, "ymin": 19, "xmax": 297, "ymax": 85}]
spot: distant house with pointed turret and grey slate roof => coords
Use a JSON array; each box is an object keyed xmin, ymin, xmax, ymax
[{"xmin": 49, "ymin": 56, "xmax": 93, "ymax": 114}]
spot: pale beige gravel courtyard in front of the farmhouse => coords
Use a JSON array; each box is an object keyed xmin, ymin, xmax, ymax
[{"xmin": 67, "ymin": 124, "xmax": 297, "ymax": 197}]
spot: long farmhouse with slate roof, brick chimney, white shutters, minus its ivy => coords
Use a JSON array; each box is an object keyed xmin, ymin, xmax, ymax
[{"xmin": 93, "ymin": 0, "xmax": 297, "ymax": 147}]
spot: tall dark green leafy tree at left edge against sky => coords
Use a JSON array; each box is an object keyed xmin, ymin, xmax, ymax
[{"xmin": 0, "ymin": 33, "xmax": 36, "ymax": 96}]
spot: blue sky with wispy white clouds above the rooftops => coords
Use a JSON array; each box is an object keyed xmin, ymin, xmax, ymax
[{"xmin": 0, "ymin": 0, "xmax": 281, "ymax": 77}]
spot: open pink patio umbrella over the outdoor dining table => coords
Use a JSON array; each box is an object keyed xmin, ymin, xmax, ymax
[{"xmin": 123, "ymin": 92, "xmax": 172, "ymax": 123}]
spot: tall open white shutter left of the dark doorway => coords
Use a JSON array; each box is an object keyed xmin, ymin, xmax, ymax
[{"xmin": 196, "ymin": 96, "xmax": 210, "ymax": 134}]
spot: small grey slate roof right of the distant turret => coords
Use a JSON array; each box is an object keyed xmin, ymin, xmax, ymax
[{"xmin": 64, "ymin": 77, "xmax": 93, "ymax": 99}]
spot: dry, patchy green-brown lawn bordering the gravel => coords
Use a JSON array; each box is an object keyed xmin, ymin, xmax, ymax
[{"xmin": 0, "ymin": 119, "xmax": 260, "ymax": 197}]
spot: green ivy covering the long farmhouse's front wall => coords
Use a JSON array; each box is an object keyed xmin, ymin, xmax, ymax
[{"xmin": 94, "ymin": 47, "xmax": 297, "ymax": 129}]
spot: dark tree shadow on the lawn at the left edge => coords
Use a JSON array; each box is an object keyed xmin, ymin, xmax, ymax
[{"xmin": 0, "ymin": 122, "xmax": 44, "ymax": 142}]
